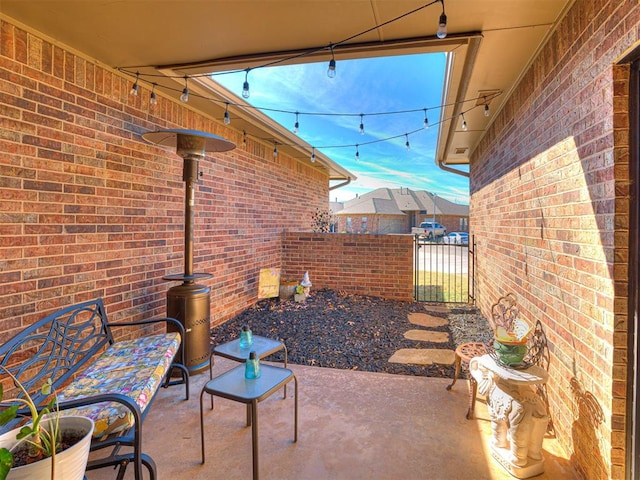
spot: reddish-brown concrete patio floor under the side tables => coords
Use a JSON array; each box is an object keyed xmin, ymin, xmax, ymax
[{"xmin": 87, "ymin": 357, "xmax": 579, "ymax": 480}]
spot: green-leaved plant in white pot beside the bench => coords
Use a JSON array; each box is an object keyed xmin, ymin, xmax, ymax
[{"xmin": 0, "ymin": 367, "xmax": 93, "ymax": 480}]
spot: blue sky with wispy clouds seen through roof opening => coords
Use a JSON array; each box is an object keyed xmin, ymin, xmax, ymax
[{"xmin": 214, "ymin": 54, "xmax": 469, "ymax": 203}]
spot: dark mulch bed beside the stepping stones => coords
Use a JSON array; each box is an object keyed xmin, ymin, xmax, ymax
[{"xmin": 211, "ymin": 290, "xmax": 490, "ymax": 378}]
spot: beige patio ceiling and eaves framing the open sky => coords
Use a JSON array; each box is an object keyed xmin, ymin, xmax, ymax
[{"xmin": 1, "ymin": 0, "xmax": 574, "ymax": 180}]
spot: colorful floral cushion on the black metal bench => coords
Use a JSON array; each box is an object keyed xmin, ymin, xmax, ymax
[{"xmin": 58, "ymin": 333, "xmax": 180, "ymax": 438}]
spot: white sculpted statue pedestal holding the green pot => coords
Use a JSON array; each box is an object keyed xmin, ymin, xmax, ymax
[{"xmin": 469, "ymin": 355, "xmax": 549, "ymax": 478}]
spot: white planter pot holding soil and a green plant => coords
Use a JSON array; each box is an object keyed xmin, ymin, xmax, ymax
[{"xmin": 0, "ymin": 415, "xmax": 93, "ymax": 480}]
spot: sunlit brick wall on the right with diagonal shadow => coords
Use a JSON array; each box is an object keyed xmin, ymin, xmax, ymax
[{"xmin": 470, "ymin": 0, "xmax": 640, "ymax": 479}]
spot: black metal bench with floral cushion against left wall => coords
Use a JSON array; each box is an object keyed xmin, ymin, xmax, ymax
[{"xmin": 0, "ymin": 299, "xmax": 189, "ymax": 480}]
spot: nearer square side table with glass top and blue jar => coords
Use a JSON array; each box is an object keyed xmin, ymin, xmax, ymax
[{"xmin": 200, "ymin": 365, "xmax": 298, "ymax": 480}]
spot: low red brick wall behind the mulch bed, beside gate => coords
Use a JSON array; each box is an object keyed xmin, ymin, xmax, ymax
[{"xmin": 282, "ymin": 232, "xmax": 413, "ymax": 301}]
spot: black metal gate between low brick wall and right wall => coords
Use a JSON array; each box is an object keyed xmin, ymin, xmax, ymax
[{"xmin": 413, "ymin": 235, "xmax": 475, "ymax": 304}]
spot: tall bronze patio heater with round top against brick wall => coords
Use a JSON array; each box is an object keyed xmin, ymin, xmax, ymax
[{"xmin": 142, "ymin": 129, "xmax": 235, "ymax": 373}]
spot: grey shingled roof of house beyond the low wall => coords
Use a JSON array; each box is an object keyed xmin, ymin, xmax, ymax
[{"xmin": 333, "ymin": 188, "xmax": 469, "ymax": 217}]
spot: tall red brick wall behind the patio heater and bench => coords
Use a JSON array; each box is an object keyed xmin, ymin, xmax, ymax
[{"xmin": 0, "ymin": 21, "xmax": 328, "ymax": 338}]
